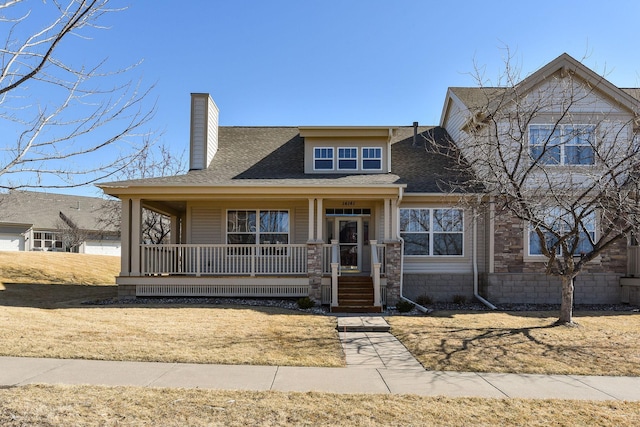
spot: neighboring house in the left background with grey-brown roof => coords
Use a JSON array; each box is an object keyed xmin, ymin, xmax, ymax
[{"xmin": 0, "ymin": 191, "xmax": 120, "ymax": 256}]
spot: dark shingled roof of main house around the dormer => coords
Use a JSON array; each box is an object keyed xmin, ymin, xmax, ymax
[{"xmin": 99, "ymin": 126, "xmax": 470, "ymax": 194}]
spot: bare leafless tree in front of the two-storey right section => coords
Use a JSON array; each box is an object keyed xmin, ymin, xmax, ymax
[{"xmin": 430, "ymin": 56, "xmax": 640, "ymax": 325}]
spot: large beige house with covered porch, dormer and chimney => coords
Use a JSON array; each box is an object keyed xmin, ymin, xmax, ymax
[{"xmin": 99, "ymin": 55, "xmax": 638, "ymax": 311}]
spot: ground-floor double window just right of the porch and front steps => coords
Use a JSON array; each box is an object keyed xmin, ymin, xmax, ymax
[{"xmin": 400, "ymin": 209, "xmax": 464, "ymax": 256}]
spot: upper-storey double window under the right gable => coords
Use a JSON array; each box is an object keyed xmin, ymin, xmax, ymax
[{"xmin": 529, "ymin": 125, "xmax": 595, "ymax": 165}]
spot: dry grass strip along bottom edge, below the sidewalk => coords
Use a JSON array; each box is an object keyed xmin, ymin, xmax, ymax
[{"xmin": 0, "ymin": 386, "xmax": 640, "ymax": 427}]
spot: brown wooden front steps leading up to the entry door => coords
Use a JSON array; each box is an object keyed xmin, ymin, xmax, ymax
[{"xmin": 331, "ymin": 276, "xmax": 382, "ymax": 313}]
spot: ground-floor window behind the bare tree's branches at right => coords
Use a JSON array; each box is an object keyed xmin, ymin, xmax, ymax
[{"xmin": 529, "ymin": 208, "xmax": 596, "ymax": 255}]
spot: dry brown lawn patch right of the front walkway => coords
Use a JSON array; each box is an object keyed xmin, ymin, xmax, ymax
[{"xmin": 388, "ymin": 312, "xmax": 640, "ymax": 376}]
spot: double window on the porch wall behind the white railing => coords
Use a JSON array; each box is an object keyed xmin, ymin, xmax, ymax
[{"xmin": 227, "ymin": 210, "xmax": 289, "ymax": 245}]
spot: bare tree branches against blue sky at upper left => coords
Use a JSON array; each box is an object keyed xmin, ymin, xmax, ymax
[{"xmin": 0, "ymin": 0, "xmax": 154, "ymax": 189}]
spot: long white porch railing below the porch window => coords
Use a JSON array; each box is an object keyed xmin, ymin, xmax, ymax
[{"xmin": 140, "ymin": 244, "xmax": 307, "ymax": 276}]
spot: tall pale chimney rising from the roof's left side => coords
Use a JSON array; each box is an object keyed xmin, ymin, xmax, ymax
[{"xmin": 189, "ymin": 93, "xmax": 218, "ymax": 170}]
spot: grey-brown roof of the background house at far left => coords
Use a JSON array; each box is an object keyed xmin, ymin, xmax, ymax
[{"xmin": 0, "ymin": 190, "xmax": 119, "ymax": 231}]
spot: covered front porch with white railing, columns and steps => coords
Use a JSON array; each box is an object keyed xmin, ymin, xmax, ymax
[{"xmin": 116, "ymin": 186, "xmax": 402, "ymax": 311}]
